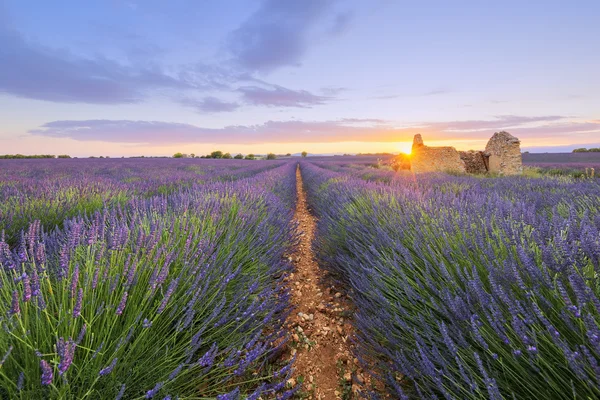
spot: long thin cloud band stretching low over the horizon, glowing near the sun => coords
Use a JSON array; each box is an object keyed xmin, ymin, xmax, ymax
[{"xmin": 30, "ymin": 116, "xmax": 600, "ymax": 145}]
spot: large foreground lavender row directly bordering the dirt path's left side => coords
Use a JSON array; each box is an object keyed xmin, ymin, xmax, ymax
[{"xmin": 0, "ymin": 164, "xmax": 295, "ymax": 399}]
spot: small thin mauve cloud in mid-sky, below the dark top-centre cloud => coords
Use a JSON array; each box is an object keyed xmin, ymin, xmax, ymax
[{"xmin": 238, "ymin": 85, "xmax": 331, "ymax": 107}]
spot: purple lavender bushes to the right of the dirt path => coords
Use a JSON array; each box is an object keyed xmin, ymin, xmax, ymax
[{"xmin": 301, "ymin": 163, "xmax": 600, "ymax": 399}]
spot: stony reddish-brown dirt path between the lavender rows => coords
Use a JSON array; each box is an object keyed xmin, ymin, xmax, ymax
[{"xmin": 287, "ymin": 164, "xmax": 364, "ymax": 400}]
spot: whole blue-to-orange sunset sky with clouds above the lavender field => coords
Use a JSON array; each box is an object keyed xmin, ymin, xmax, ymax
[{"xmin": 0, "ymin": 0, "xmax": 600, "ymax": 157}]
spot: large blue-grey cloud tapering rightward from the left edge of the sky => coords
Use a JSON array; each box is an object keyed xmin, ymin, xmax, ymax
[{"xmin": 0, "ymin": 24, "xmax": 197, "ymax": 104}]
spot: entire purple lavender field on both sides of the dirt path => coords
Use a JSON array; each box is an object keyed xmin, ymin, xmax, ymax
[{"xmin": 0, "ymin": 157, "xmax": 600, "ymax": 399}]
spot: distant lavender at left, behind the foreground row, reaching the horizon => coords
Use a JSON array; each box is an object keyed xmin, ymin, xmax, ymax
[{"xmin": 0, "ymin": 159, "xmax": 281, "ymax": 244}]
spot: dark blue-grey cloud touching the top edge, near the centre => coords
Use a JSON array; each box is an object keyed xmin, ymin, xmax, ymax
[{"xmin": 227, "ymin": 0, "xmax": 338, "ymax": 72}]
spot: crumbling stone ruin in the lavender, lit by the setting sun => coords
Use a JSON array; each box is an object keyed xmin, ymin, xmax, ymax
[{"xmin": 410, "ymin": 131, "xmax": 523, "ymax": 175}]
